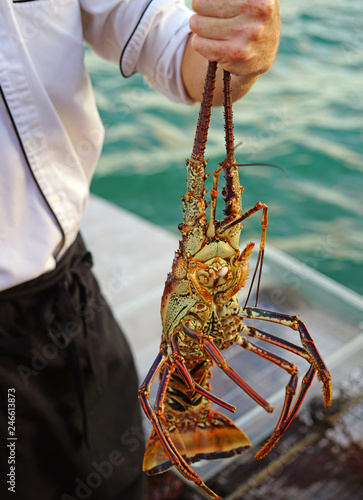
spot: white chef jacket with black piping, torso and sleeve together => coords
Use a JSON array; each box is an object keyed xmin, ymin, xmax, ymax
[{"xmin": 0, "ymin": 0, "xmax": 191, "ymax": 290}]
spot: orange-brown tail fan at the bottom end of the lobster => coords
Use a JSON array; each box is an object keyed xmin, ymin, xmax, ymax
[{"xmin": 143, "ymin": 407, "xmax": 251, "ymax": 475}]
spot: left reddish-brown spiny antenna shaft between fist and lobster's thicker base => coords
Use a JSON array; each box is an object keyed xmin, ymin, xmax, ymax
[{"xmin": 191, "ymin": 61, "xmax": 217, "ymax": 162}]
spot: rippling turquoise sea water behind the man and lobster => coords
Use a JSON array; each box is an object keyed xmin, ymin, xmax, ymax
[{"xmin": 87, "ymin": 0, "xmax": 363, "ymax": 294}]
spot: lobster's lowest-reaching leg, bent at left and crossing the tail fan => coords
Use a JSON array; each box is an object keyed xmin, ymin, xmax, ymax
[{"xmin": 139, "ymin": 351, "xmax": 221, "ymax": 499}]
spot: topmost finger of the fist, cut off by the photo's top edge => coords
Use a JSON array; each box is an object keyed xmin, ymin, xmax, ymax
[{"xmin": 192, "ymin": 0, "xmax": 279, "ymax": 19}]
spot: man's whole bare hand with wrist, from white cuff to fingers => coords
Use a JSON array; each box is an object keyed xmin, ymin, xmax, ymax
[{"xmin": 182, "ymin": 0, "xmax": 280, "ymax": 105}]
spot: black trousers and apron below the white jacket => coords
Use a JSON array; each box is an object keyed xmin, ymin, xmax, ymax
[{"xmin": 0, "ymin": 236, "xmax": 144, "ymax": 500}]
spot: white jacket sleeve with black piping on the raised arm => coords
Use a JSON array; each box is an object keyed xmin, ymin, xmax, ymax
[{"xmin": 80, "ymin": 0, "xmax": 192, "ymax": 103}]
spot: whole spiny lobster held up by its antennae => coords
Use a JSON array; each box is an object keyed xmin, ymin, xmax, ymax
[{"xmin": 139, "ymin": 62, "xmax": 332, "ymax": 498}]
